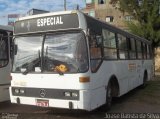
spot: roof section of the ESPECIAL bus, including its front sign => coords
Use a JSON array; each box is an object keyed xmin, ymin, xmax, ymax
[{"xmin": 14, "ymin": 10, "xmax": 150, "ymax": 43}]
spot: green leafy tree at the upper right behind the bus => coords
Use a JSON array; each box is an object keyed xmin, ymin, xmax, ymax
[{"xmin": 110, "ymin": 0, "xmax": 160, "ymax": 51}]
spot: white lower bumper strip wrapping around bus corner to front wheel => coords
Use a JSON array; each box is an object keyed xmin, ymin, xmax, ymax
[{"xmin": 10, "ymin": 84, "xmax": 105, "ymax": 111}]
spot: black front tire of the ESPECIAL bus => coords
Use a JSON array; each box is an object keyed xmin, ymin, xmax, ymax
[{"xmin": 106, "ymin": 82, "xmax": 113, "ymax": 110}]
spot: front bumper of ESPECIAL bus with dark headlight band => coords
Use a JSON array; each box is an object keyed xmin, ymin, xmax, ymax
[{"xmin": 10, "ymin": 87, "xmax": 91, "ymax": 111}]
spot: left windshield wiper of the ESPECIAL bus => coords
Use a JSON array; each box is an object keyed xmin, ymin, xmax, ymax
[{"xmin": 22, "ymin": 50, "xmax": 41, "ymax": 75}]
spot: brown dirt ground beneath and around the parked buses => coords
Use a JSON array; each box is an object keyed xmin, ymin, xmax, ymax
[{"xmin": 0, "ymin": 76, "xmax": 160, "ymax": 119}]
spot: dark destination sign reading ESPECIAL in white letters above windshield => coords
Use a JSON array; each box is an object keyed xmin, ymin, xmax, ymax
[{"xmin": 14, "ymin": 14, "xmax": 79, "ymax": 35}]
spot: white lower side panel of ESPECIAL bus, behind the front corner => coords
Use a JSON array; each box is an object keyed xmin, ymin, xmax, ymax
[{"xmin": 90, "ymin": 60, "xmax": 153, "ymax": 96}]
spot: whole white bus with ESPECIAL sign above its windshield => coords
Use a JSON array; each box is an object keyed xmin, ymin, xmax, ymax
[{"xmin": 10, "ymin": 11, "xmax": 153, "ymax": 111}]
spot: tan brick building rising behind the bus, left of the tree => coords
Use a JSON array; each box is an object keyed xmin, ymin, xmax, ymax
[{"xmin": 83, "ymin": 0, "xmax": 132, "ymax": 30}]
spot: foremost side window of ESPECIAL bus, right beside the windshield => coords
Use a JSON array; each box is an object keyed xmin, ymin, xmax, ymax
[{"xmin": 89, "ymin": 35, "xmax": 102, "ymax": 72}]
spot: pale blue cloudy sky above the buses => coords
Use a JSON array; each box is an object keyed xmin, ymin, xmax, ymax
[{"xmin": 0, "ymin": 0, "xmax": 85, "ymax": 25}]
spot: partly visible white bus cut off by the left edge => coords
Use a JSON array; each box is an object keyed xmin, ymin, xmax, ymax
[{"xmin": 0, "ymin": 25, "xmax": 13, "ymax": 102}]
